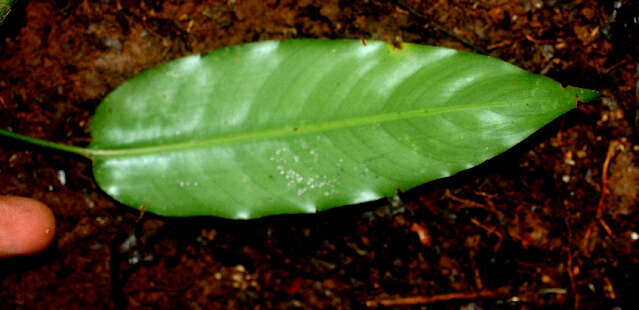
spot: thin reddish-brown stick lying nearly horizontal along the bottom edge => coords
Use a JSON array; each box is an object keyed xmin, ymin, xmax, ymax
[{"xmin": 366, "ymin": 287, "xmax": 509, "ymax": 308}]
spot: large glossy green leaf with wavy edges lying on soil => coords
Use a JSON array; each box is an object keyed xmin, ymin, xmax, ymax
[{"xmin": 0, "ymin": 40, "xmax": 598, "ymax": 219}]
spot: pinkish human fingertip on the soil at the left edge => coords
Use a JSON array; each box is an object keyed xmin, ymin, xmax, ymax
[{"xmin": 0, "ymin": 196, "xmax": 55, "ymax": 257}]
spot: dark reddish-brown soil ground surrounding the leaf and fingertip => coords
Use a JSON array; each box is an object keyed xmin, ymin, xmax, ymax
[{"xmin": 0, "ymin": 0, "xmax": 639, "ymax": 310}]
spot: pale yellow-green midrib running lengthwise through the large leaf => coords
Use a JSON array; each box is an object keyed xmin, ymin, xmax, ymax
[{"xmin": 87, "ymin": 102, "xmax": 521, "ymax": 158}]
